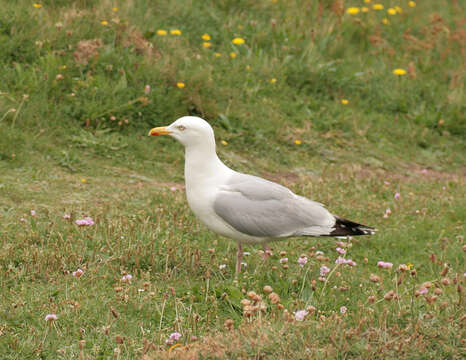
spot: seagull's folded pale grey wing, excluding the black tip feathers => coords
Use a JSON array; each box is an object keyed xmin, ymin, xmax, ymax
[{"xmin": 214, "ymin": 173, "xmax": 335, "ymax": 238}]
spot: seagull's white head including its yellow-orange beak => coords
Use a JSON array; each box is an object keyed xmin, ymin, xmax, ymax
[{"xmin": 149, "ymin": 116, "xmax": 215, "ymax": 148}]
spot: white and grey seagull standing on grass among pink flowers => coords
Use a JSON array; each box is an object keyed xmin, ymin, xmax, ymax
[{"xmin": 149, "ymin": 116, "xmax": 375, "ymax": 275}]
